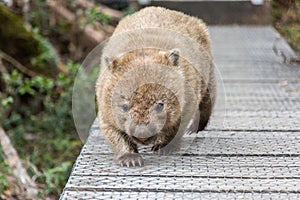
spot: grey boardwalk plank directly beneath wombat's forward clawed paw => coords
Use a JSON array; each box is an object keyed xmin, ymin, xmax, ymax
[{"xmin": 74, "ymin": 153, "xmax": 300, "ymax": 168}]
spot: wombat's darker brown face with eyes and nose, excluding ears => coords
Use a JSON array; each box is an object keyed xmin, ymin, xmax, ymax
[{"xmin": 122, "ymin": 84, "xmax": 180, "ymax": 144}]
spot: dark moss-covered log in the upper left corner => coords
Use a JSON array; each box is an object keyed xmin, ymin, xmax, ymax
[{"xmin": 0, "ymin": 5, "xmax": 58, "ymax": 76}]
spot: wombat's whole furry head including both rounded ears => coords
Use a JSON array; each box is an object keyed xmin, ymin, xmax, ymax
[{"xmin": 106, "ymin": 50, "xmax": 184, "ymax": 144}]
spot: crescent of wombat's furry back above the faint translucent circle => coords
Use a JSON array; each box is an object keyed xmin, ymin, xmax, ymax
[{"xmin": 114, "ymin": 7, "xmax": 210, "ymax": 52}]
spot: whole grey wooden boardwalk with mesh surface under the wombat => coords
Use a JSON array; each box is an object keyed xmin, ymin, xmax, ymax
[{"xmin": 61, "ymin": 26, "xmax": 300, "ymax": 200}]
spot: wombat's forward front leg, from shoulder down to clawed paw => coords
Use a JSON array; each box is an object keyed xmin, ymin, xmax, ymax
[{"xmin": 103, "ymin": 128, "xmax": 144, "ymax": 167}]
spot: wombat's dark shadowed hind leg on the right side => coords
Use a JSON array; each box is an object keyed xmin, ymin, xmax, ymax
[{"xmin": 197, "ymin": 90, "xmax": 213, "ymax": 132}]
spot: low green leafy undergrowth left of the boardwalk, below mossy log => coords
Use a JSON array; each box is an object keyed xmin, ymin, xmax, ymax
[{"xmin": 0, "ymin": 62, "xmax": 81, "ymax": 196}]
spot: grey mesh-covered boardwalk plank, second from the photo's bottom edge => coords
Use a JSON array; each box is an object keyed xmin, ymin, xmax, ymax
[{"xmin": 66, "ymin": 176, "xmax": 300, "ymax": 193}]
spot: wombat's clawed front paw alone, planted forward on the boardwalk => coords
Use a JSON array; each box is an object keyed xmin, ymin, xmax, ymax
[{"xmin": 115, "ymin": 153, "xmax": 144, "ymax": 167}]
